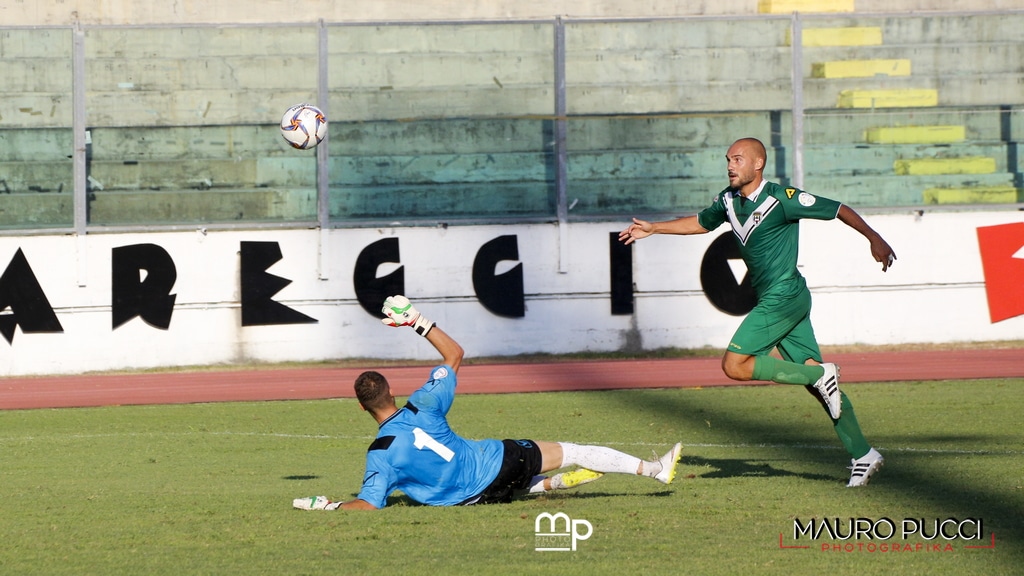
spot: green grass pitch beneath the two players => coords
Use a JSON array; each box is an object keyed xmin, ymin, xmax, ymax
[{"xmin": 0, "ymin": 380, "xmax": 1024, "ymax": 576}]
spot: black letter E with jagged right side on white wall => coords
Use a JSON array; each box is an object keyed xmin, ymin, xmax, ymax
[{"xmin": 240, "ymin": 242, "xmax": 316, "ymax": 326}]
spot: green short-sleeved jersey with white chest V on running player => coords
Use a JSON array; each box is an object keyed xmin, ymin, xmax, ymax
[{"xmin": 697, "ymin": 180, "xmax": 842, "ymax": 298}]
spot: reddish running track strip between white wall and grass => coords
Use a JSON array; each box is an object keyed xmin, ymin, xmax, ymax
[{"xmin": 0, "ymin": 348, "xmax": 1024, "ymax": 410}]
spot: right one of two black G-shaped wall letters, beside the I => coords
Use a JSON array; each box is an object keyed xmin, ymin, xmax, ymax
[{"xmin": 473, "ymin": 235, "xmax": 526, "ymax": 318}]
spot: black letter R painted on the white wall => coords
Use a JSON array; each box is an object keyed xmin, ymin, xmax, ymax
[{"xmin": 111, "ymin": 244, "xmax": 178, "ymax": 330}]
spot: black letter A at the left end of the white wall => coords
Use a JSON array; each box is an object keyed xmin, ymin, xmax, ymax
[{"xmin": 0, "ymin": 248, "xmax": 63, "ymax": 344}]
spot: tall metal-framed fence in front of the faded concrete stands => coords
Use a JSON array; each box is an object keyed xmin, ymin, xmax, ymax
[{"xmin": 0, "ymin": 10, "xmax": 1024, "ymax": 234}]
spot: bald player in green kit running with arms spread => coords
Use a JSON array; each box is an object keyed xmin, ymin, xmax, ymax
[{"xmin": 618, "ymin": 138, "xmax": 896, "ymax": 487}]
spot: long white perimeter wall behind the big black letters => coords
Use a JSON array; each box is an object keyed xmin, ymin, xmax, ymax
[{"xmin": 0, "ymin": 211, "xmax": 1024, "ymax": 375}]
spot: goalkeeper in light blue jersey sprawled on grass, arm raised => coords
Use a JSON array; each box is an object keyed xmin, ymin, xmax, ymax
[{"xmin": 292, "ymin": 296, "xmax": 682, "ymax": 510}]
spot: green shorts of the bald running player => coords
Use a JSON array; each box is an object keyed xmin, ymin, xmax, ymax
[{"xmin": 729, "ymin": 286, "xmax": 821, "ymax": 364}]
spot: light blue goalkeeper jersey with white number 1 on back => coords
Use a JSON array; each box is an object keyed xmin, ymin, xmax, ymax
[{"xmin": 358, "ymin": 366, "xmax": 505, "ymax": 508}]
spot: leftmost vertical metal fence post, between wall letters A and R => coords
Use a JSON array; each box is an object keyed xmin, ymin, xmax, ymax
[{"xmin": 71, "ymin": 20, "xmax": 89, "ymax": 286}]
